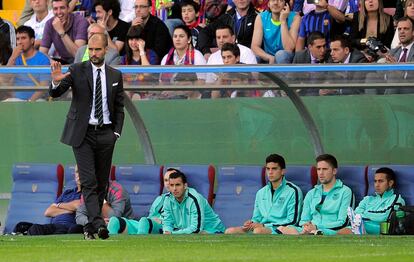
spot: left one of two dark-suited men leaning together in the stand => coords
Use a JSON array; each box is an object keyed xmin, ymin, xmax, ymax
[{"xmin": 292, "ymin": 31, "xmax": 329, "ymax": 96}]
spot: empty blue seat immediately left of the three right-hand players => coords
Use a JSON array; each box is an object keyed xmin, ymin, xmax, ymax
[{"xmin": 214, "ymin": 166, "xmax": 264, "ymax": 227}]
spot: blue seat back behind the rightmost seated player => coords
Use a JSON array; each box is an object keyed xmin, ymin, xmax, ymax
[{"xmin": 368, "ymin": 165, "xmax": 414, "ymax": 206}]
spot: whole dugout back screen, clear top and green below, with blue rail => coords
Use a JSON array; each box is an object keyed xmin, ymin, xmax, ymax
[{"xmin": 0, "ymin": 64, "xmax": 414, "ymax": 190}]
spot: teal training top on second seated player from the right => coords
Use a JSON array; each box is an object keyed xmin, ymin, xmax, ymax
[{"xmin": 299, "ymin": 179, "xmax": 353, "ymax": 230}]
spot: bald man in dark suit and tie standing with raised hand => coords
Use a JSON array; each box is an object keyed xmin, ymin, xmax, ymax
[{"xmin": 49, "ymin": 34, "xmax": 124, "ymax": 240}]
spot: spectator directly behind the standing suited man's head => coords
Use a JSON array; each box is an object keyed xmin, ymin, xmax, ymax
[{"xmin": 74, "ymin": 23, "xmax": 120, "ymax": 65}]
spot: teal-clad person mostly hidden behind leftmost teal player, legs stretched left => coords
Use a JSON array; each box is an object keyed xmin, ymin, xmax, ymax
[{"xmin": 108, "ymin": 168, "xmax": 177, "ymax": 235}]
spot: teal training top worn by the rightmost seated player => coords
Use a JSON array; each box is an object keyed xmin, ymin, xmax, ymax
[{"xmin": 355, "ymin": 189, "xmax": 405, "ymax": 225}]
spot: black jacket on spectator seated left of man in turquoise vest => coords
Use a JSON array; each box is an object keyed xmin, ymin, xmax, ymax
[{"xmin": 198, "ymin": 4, "xmax": 259, "ymax": 54}]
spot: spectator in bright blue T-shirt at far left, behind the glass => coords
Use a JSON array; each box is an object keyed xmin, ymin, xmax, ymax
[{"xmin": 7, "ymin": 25, "xmax": 50, "ymax": 101}]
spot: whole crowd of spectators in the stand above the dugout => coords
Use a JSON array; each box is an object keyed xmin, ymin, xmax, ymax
[{"xmin": 0, "ymin": 0, "xmax": 414, "ymax": 100}]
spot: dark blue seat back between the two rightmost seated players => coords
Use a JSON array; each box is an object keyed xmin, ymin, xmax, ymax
[{"xmin": 336, "ymin": 166, "xmax": 368, "ymax": 206}]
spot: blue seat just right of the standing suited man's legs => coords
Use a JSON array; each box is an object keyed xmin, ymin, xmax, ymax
[{"xmin": 115, "ymin": 165, "xmax": 163, "ymax": 218}]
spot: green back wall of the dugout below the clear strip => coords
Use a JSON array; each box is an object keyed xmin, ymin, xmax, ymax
[{"xmin": 0, "ymin": 95, "xmax": 414, "ymax": 192}]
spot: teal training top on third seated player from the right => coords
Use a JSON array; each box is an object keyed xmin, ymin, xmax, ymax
[{"xmin": 252, "ymin": 177, "xmax": 303, "ymax": 226}]
